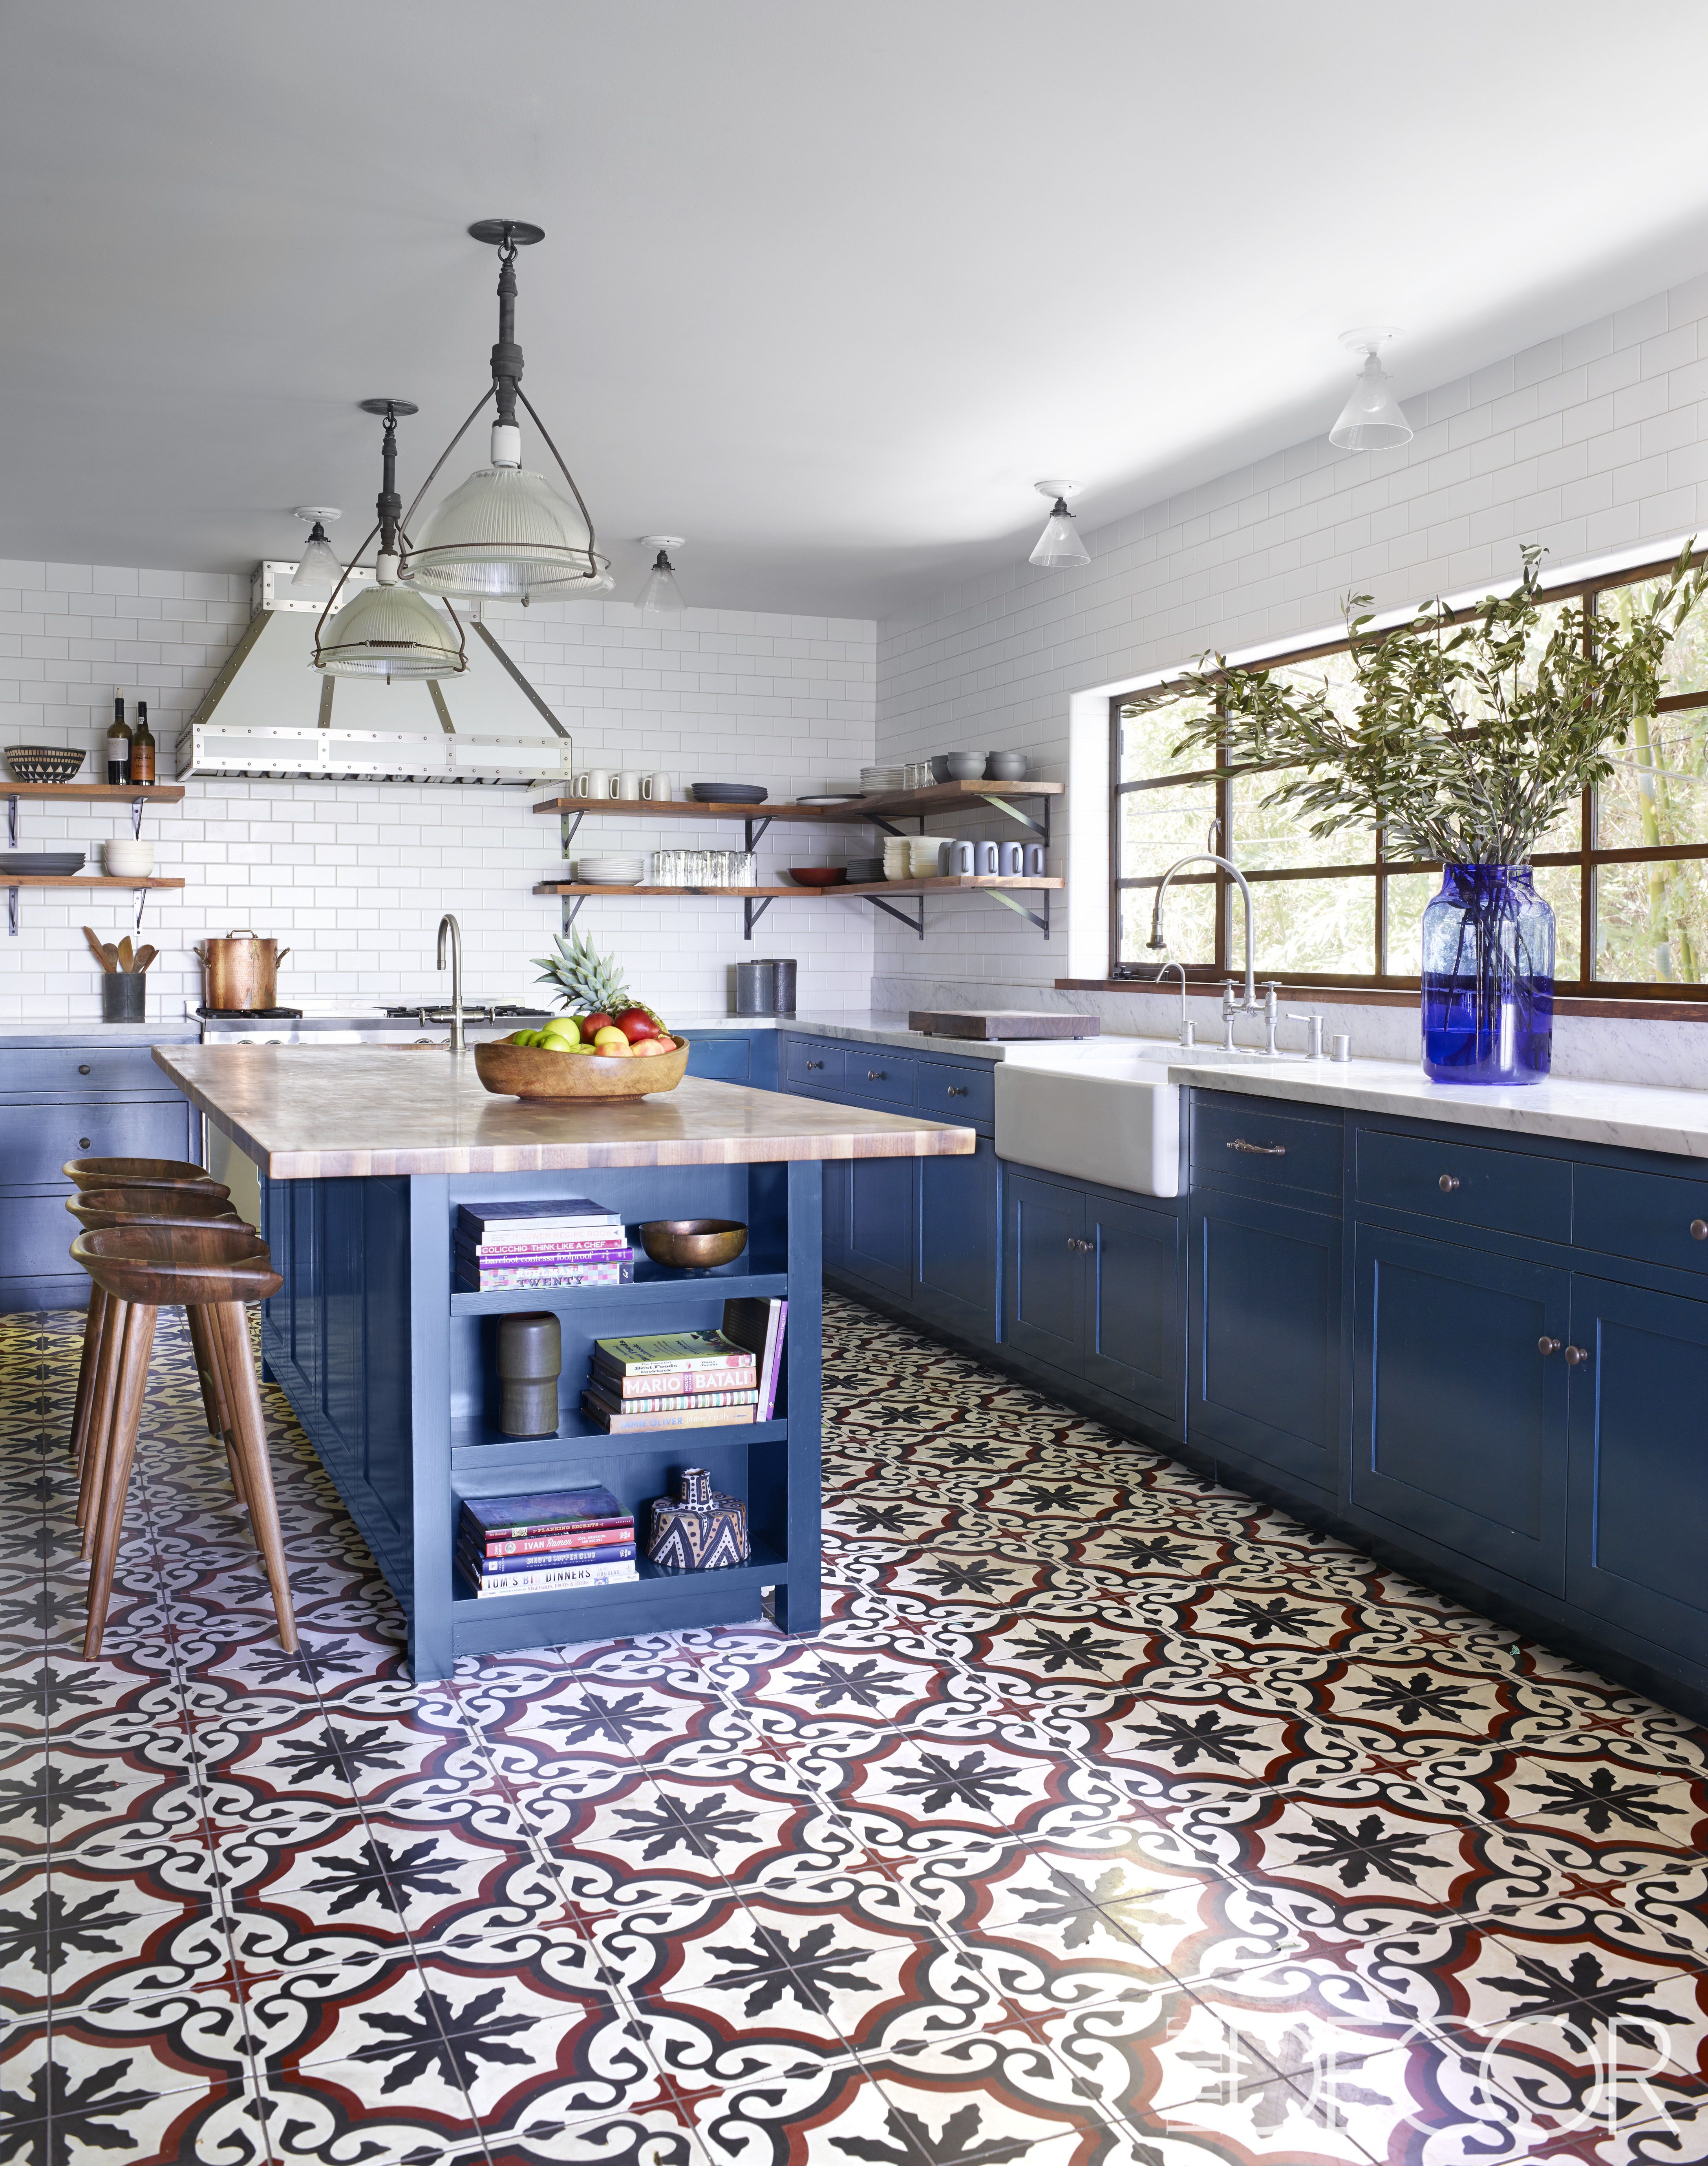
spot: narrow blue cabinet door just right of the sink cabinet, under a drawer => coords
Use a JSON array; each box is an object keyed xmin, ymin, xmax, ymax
[{"xmin": 1186, "ymin": 1178, "xmax": 1340, "ymax": 1497}]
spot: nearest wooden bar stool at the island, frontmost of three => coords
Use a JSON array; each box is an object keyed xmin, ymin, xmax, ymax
[{"xmin": 71, "ymin": 1222, "xmax": 297, "ymax": 1659}]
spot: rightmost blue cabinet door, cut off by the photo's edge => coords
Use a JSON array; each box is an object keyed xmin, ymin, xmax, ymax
[{"xmin": 1565, "ymin": 1273, "xmax": 1708, "ymax": 1668}]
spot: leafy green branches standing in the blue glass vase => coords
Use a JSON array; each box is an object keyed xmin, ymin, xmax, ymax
[{"xmin": 1168, "ymin": 537, "xmax": 1708, "ymax": 864}]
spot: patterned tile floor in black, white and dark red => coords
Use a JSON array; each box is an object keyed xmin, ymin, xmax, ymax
[{"xmin": 0, "ymin": 1304, "xmax": 1708, "ymax": 2166}]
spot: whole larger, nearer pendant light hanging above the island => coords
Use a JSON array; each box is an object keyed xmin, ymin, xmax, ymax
[{"xmin": 399, "ymin": 219, "xmax": 616, "ymax": 600}]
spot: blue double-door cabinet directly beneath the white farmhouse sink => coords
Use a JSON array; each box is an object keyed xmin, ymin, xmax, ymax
[{"xmin": 1004, "ymin": 1168, "xmax": 1181, "ymax": 1432}]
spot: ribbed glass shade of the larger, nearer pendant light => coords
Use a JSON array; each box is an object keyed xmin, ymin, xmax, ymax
[{"xmin": 401, "ymin": 466, "xmax": 613, "ymax": 600}]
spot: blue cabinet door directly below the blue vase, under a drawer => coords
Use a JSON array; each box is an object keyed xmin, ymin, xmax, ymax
[{"xmin": 1350, "ymin": 1230, "xmax": 1569, "ymax": 1596}]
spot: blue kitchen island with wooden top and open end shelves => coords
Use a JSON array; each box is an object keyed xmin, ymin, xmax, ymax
[{"xmin": 154, "ymin": 1046, "xmax": 975, "ymax": 1683}]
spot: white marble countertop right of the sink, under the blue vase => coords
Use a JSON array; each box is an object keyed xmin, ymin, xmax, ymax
[{"xmin": 1168, "ymin": 1055, "xmax": 1708, "ymax": 1159}]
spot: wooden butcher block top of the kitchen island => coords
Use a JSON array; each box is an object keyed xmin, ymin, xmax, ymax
[{"xmin": 154, "ymin": 1046, "xmax": 978, "ymax": 1181}]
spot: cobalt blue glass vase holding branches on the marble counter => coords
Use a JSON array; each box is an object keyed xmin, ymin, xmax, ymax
[{"xmin": 1424, "ymin": 864, "xmax": 1554, "ymax": 1083}]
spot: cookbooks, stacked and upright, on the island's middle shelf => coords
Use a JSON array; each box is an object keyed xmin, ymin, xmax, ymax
[{"xmin": 581, "ymin": 1300, "xmax": 789, "ymax": 1436}]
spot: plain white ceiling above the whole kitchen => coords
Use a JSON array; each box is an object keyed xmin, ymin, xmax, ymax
[{"xmin": 0, "ymin": 0, "xmax": 1708, "ymax": 615}]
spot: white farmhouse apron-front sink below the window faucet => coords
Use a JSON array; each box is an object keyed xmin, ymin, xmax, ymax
[{"xmin": 997, "ymin": 1038, "xmax": 1181, "ymax": 1195}]
